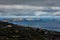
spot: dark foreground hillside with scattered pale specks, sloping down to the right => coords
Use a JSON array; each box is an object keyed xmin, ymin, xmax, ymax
[{"xmin": 0, "ymin": 21, "xmax": 60, "ymax": 40}]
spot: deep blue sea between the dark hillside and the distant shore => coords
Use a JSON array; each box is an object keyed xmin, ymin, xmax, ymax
[{"xmin": 0, "ymin": 18, "xmax": 60, "ymax": 31}]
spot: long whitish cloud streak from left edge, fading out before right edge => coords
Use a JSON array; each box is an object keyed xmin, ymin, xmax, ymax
[{"xmin": 0, "ymin": 5, "xmax": 47, "ymax": 10}]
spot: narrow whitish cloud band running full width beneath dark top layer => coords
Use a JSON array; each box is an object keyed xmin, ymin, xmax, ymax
[{"xmin": 0, "ymin": 5, "xmax": 60, "ymax": 10}]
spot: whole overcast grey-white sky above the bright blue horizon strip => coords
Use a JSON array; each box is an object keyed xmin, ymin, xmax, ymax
[{"xmin": 0, "ymin": 0, "xmax": 60, "ymax": 16}]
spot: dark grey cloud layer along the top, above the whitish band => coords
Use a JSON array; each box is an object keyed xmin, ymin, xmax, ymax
[{"xmin": 0, "ymin": 0, "xmax": 60, "ymax": 6}]
